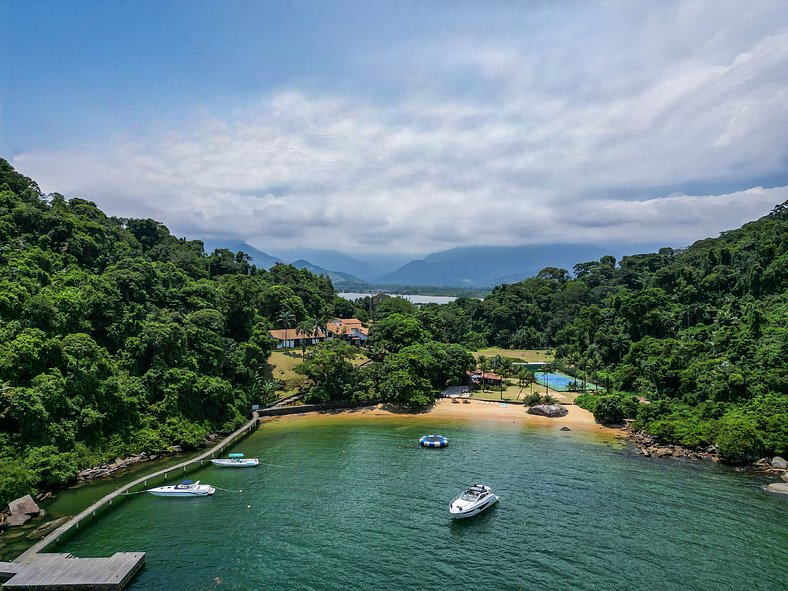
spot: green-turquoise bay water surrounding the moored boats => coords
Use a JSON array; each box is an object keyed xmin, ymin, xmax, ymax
[{"xmin": 59, "ymin": 417, "xmax": 788, "ymax": 591}]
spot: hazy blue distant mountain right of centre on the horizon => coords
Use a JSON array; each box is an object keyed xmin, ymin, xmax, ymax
[{"xmin": 374, "ymin": 244, "xmax": 640, "ymax": 287}]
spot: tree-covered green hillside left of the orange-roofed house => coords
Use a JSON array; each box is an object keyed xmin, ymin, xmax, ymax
[{"xmin": 0, "ymin": 160, "xmax": 348, "ymax": 504}]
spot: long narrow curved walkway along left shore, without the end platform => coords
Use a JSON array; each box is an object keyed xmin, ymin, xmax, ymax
[{"xmin": 16, "ymin": 412, "xmax": 260, "ymax": 563}]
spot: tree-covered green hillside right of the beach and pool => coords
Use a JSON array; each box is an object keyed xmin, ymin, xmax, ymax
[{"xmin": 410, "ymin": 203, "xmax": 788, "ymax": 462}]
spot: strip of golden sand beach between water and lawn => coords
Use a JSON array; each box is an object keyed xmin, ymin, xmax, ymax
[{"xmin": 268, "ymin": 398, "xmax": 626, "ymax": 438}]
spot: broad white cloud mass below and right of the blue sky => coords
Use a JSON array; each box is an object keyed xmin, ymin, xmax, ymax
[{"xmin": 14, "ymin": 2, "xmax": 788, "ymax": 253}]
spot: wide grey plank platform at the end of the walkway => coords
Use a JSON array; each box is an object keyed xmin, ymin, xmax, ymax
[{"xmin": 3, "ymin": 552, "xmax": 145, "ymax": 591}]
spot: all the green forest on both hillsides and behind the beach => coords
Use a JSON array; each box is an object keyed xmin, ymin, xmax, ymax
[{"xmin": 0, "ymin": 160, "xmax": 788, "ymax": 502}]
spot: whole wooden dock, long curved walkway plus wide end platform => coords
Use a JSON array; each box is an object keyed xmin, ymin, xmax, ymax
[{"xmin": 0, "ymin": 412, "xmax": 260, "ymax": 591}]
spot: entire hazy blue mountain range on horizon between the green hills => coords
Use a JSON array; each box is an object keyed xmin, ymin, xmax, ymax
[{"xmin": 204, "ymin": 239, "xmax": 658, "ymax": 289}]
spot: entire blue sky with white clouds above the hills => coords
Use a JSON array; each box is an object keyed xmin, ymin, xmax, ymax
[{"xmin": 0, "ymin": 0, "xmax": 788, "ymax": 255}]
